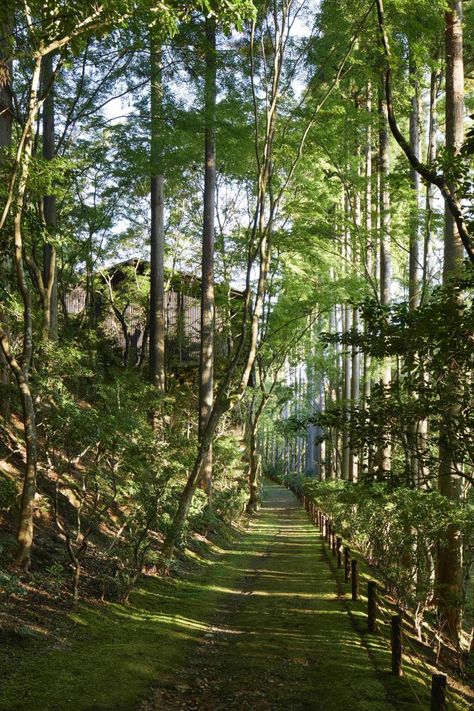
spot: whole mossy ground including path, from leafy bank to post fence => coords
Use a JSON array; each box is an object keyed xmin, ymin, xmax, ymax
[{"xmin": 0, "ymin": 483, "xmax": 472, "ymax": 711}]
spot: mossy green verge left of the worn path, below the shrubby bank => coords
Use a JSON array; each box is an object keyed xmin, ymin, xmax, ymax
[{"xmin": 0, "ymin": 536, "xmax": 246, "ymax": 711}]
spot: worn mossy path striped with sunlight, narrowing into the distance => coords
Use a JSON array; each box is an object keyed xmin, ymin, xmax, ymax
[{"xmin": 140, "ymin": 483, "xmax": 393, "ymax": 711}]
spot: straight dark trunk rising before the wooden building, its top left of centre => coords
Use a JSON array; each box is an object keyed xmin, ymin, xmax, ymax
[{"xmin": 149, "ymin": 37, "xmax": 166, "ymax": 392}]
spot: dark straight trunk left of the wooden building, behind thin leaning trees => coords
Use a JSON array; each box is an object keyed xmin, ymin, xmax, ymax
[{"xmin": 42, "ymin": 54, "xmax": 58, "ymax": 340}]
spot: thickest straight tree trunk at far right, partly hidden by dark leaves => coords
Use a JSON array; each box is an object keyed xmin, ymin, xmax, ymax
[{"xmin": 435, "ymin": 0, "xmax": 464, "ymax": 642}]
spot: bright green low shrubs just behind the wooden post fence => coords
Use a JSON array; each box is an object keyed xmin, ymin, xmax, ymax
[{"xmin": 277, "ymin": 474, "xmax": 474, "ymax": 609}]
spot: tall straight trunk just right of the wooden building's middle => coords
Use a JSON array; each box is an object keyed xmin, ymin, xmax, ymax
[{"xmin": 199, "ymin": 17, "xmax": 217, "ymax": 505}]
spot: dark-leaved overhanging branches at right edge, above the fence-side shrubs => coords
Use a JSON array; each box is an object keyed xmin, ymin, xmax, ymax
[{"xmin": 312, "ymin": 267, "xmax": 474, "ymax": 488}]
